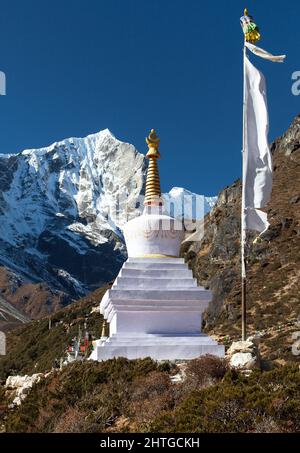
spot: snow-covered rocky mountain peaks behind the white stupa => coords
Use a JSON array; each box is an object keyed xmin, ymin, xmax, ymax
[{"xmin": 0, "ymin": 129, "xmax": 216, "ymax": 295}]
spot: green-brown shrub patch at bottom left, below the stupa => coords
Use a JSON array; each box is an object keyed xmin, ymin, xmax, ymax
[{"xmin": 7, "ymin": 358, "xmax": 157, "ymax": 432}]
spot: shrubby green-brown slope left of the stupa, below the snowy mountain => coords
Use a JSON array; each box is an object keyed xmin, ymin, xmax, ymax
[{"xmin": 0, "ymin": 287, "xmax": 106, "ymax": 382}]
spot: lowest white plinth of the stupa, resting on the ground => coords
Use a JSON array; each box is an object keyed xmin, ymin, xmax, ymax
[{"xmin": 90, "ymin": 334, "xmax": 225, "ymax": 361}]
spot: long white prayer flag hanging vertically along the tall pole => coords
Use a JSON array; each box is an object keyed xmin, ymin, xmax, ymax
[{"xmin": 243, "ymin": 56, "xmax": 272, "ymax": 233}]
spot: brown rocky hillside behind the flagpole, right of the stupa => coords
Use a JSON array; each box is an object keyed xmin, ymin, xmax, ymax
[{"xmin": 183, "ymin": 116, "xmax": 300, "ymax": 360}]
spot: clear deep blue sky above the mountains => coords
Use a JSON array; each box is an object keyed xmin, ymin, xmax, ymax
[{"xmin": 0, "ymin": 0, "xmax": 300, "ymax": 195}]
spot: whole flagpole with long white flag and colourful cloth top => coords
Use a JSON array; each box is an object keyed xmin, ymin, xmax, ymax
[{"xmin": 240, "ymin": 8, "xmax": 286, "ymax": 341}]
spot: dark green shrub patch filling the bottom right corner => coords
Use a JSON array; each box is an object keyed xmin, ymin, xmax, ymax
[{"xmin": 150, "ymin": 365, "xmax": 300, "ymax": 433}]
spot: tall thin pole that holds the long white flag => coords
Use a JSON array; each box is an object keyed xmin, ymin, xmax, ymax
[{"xmin": 241, "ymin": 41, "xmax": 247, "ymax": 341}]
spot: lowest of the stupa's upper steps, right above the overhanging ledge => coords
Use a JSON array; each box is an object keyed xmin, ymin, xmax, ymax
[{"xmin": 113, "ymin": 275, "xmax": 197, "ymax": 289}]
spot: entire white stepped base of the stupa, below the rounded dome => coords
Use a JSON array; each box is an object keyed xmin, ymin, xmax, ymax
[{"xmin": 91, "ymin": 258, "xmax": 225, "ymax": 361}]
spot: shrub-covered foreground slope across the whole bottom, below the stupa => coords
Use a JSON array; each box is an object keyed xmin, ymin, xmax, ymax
[{"xmin": 0, "ymin": 357, "xmax": 300, "ymax": 433}]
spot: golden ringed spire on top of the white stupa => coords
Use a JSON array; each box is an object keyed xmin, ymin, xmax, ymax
[{"xmin": 144, "ymin": 129, "xmax": 162, "ymax": 206}]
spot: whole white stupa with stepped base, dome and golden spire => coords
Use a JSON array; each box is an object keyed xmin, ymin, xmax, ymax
[{"xmin": 91, "ymin": 130, "xmax": 224, "ymax": 361}]
